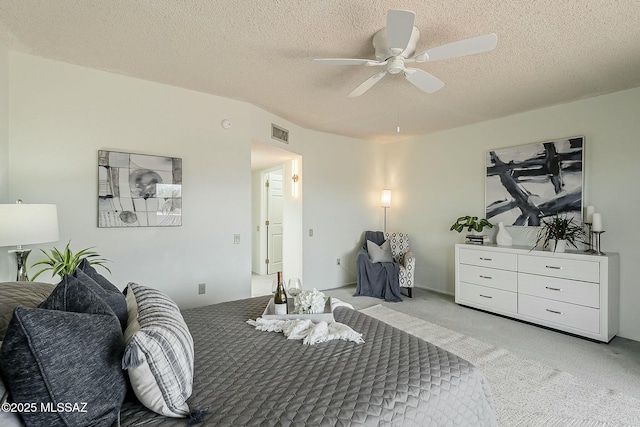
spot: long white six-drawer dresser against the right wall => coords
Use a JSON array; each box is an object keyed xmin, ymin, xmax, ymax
[{"xmin": 455, "ymin": 244, "xmax": 620, "ymax": 342}]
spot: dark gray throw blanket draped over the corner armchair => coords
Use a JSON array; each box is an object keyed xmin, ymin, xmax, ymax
[{"xmin": 354, "ymin": 231, "xmax": 402, "ymax": 302}]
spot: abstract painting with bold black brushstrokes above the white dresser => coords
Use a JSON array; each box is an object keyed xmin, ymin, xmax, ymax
[{"xmin": 485, "ymin": 136, "xmax": 584, "ymax": 226}]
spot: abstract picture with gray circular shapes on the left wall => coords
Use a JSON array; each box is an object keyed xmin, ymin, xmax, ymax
[{"xmin": 98, "ymin": 150, "xmax": 182, "ymax": 228}]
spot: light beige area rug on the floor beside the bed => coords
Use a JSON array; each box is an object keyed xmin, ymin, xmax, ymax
[{"xmin": 360, "ymin": 305, "xmax": 640, "ymax": 427}]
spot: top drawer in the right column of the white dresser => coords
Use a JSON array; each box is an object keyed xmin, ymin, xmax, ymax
[{"xmin": 518, "ymin": 255, "xmax": 600, "ymax": 283}]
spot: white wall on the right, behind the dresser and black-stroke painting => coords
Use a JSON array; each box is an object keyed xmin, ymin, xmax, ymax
[{"xmin": 385, "ymin": 88, "xmax": 640, "ymax": 340}]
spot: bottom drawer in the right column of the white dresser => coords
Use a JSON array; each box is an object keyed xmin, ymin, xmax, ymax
[{"xmin": 518, "ymin": 294, "xmax": 600, "ymax": 334}]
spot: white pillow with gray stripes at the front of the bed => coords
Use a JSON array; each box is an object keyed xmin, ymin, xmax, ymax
[{"xmin": 122, "ymin": 283, "xmax": 193, "ymax": 417}]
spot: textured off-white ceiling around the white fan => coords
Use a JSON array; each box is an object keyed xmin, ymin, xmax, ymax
[{"xmin": 0, "ymin": 0, "xmax": 640, "ymax": 142}]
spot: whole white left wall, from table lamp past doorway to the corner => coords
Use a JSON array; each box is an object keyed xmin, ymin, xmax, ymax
[{"xmin": 0, "ymin": 52, "xmax": 383, "ymax": 307}]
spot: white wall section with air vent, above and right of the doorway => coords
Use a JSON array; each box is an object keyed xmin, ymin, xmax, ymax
[{"xmin": 246, "ymin": 109, "xmax": 384, "ymax": 290}]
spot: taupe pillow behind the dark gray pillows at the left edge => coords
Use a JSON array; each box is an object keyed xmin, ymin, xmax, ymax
[{"xmin": 0, "ymin": 282, "xmax": 55, "ymax": 341}]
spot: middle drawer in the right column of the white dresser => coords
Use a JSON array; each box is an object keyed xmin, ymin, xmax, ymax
[{"xmin": 518, "ymin": 273, "xmax": 600, "ymax": 308}]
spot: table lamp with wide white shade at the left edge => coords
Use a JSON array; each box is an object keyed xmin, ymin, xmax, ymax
[{"xmin": 0, "ymin": 200, "xmax": 59, "ymax": 282}]
